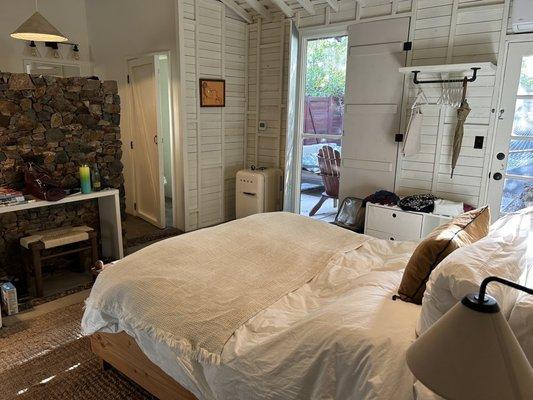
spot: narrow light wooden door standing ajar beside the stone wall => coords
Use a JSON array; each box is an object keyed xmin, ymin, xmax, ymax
[{"xmin": 128, "ymin": 56, "xmax": 165, "ymax": 228}]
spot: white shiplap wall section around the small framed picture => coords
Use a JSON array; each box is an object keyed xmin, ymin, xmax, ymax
[{"xmin": 179, "ymin": 0, "xmax": 248, "ymax": 230}]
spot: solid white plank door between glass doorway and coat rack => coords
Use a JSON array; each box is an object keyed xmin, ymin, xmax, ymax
[{"xmin": 340, "ymin": 18, "xmax": 409, "ymax": 200}]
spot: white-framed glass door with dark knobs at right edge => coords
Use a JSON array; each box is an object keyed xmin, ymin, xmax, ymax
[{"xmin": 489, "ymin": 42, "xmax": 533, "ymax": 217}]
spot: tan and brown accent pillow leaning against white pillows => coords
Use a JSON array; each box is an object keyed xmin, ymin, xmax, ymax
[{"xmin": 398, "ymin": 207, "xmax": 490, "ymax": 304}]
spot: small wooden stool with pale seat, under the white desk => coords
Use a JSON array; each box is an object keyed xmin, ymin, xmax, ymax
[{"xmin": 20, "ymin": 226, "xmax": 98, "ymax": 297}]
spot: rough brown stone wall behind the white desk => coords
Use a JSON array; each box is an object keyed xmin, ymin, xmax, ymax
[{"xmin": 0, "ymin": 73, "xmax": 124, "ymax": 278}]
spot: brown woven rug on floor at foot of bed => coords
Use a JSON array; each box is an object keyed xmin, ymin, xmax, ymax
[{"xmin": 0, "ymin": 303, "xmax": 154, "ymax": 400}]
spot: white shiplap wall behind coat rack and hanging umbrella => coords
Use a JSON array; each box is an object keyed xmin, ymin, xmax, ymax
[{"xmin": 396, "ymin": 0, "xmax": 507, "ymax": 206}]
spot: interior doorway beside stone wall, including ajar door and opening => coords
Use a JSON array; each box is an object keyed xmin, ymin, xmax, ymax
[{"xmin": 128, "ymin": 53, "xmax": 175, "ymax": 229}]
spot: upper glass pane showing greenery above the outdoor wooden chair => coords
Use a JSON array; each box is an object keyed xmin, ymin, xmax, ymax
[{"xmin": 304, "ymin": 36, "xmax": 348, "ymax": 135}]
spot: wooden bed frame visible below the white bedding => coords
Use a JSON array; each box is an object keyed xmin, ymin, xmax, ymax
[{"xmin": 91, "ymin": 332, "xmax": 197, "ymax": 400}]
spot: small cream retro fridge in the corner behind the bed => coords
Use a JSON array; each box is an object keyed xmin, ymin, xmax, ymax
[{"xmin": 235, "ymin": 168, "xmax": 281, "ymax": 218}]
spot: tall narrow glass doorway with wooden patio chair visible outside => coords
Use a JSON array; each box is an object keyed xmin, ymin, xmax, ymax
[{"xmin": 295, "ymin": 32, "xmax": 348, "ymax": 222}]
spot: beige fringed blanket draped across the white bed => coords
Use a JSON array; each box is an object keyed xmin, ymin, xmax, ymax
[{"xmin": 86, "ymin": 213, "xmax": 366, "ymax": 364}]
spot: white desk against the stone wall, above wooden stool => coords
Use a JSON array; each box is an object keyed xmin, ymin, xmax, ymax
[{"xmin": 0, "ymin": 189, "xmax": 124, "ymax": 260}]
